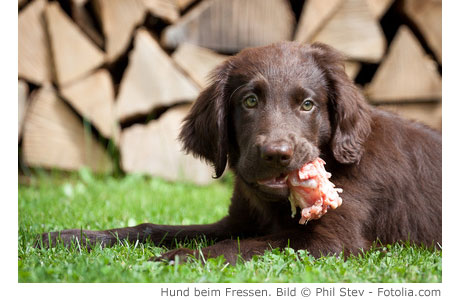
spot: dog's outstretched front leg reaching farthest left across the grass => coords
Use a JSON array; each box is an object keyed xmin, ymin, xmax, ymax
[{"xmin": 37, "ymin": 216, "xmax": 241, "ymax": 247}]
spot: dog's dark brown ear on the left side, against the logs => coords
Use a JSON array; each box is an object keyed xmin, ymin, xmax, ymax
[{"xmin": 179, "ymin": 60, "xmax": 231, "ymax": 178}]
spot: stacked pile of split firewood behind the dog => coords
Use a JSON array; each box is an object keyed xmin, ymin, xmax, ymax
[{"xmin": 18, "ymin": 0, "xmax": 442, "ymax": 184}]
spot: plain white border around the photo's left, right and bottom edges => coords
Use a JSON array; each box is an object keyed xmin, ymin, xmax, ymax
[{"xmin": 6, "ymin": 0, "xmax": 460, "ymax": 299}]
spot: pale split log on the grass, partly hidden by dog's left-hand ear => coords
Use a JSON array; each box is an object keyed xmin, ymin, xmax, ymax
[{"xmin": 120, "ymin": 105, "xmax": 213, "ymax": 184}]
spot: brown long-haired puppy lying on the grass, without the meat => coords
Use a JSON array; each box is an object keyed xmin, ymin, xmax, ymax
[{"xmin": 42, "ymin": 42, "xmax": 442, "ymax": 263}]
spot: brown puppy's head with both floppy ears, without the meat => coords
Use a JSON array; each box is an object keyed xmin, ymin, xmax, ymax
[{"xmin": 180, "ymin": 42, "xmax": 370, "ymax": 197}]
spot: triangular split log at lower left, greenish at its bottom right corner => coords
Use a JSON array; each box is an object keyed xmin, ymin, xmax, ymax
[{"xmin": 22, "ymin": 85, "xmax": 112, "ymax": 172}]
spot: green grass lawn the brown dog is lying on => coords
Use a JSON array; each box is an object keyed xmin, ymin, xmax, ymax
[{"xmin": 18, "ymin": 170, "xmax": 442, "ymax": 282}]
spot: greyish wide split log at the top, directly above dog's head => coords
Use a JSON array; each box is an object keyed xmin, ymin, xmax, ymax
[{"xmin": 162, "ymin": 0, "xmax": 295, "ymax": 52}]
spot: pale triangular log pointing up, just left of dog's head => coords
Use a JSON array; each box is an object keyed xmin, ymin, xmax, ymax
[{"xmin": 116, "ymin": 29, "xmax": 198, "ymax": 121}]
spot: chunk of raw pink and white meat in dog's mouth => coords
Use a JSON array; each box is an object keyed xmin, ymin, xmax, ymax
[{"xmin": 287, "ymin": 157, "xmax": 342, "ymax": 224}]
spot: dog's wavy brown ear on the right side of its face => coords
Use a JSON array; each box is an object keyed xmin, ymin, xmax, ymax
[{"xmin": 311, "ymin": 43, "xmax": 371, "ymax": 164}]
